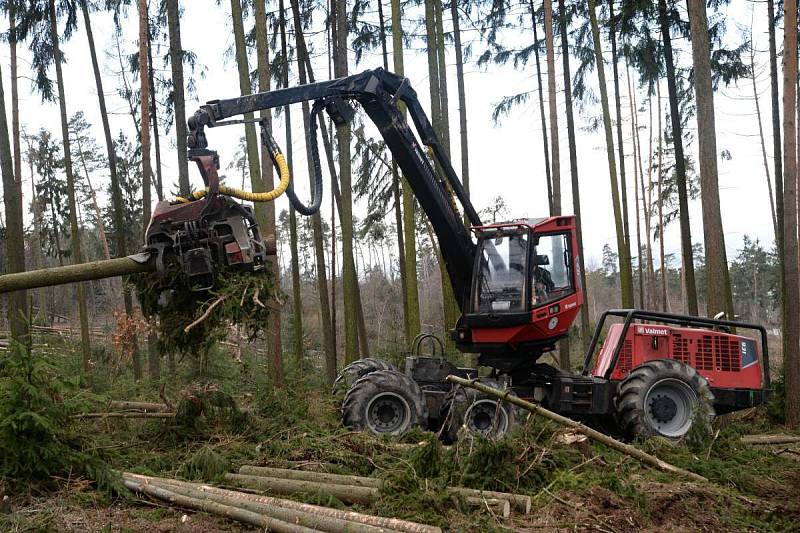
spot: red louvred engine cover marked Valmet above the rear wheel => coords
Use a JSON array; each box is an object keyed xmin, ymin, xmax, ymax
[{"xmin": 592, "ymin": 324, "xmax": 763, "ymax": 389}]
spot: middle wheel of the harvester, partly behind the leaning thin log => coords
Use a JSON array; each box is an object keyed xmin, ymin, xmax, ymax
[{"xmin": 441, "ymin": 378, "xmax": 518, "ymax": 442}]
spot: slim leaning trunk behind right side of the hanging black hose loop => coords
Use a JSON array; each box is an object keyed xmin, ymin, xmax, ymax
[{"xmin": 291, "ymin": 0, "xmax": 336, "ymax": 385}]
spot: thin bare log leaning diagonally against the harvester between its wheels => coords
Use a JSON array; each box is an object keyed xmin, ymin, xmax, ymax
[{"xmin": 447, "ymin": 376, "xmax": 708, "ymax": 482}]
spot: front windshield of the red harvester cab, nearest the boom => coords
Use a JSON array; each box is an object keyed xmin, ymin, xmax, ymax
[{"xmin": 473, "ymin": 232, "xmax": 528, "ymax": 313}]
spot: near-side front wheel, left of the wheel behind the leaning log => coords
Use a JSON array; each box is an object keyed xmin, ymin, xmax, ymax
[{"xmin": 342, "ymin": 370, "xmax": 428, "ymax": 435}]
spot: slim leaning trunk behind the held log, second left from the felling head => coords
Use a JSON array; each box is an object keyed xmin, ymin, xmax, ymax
[{"xmin": 48, "ymin": 0, "xmax": 92, "ymax": 372}]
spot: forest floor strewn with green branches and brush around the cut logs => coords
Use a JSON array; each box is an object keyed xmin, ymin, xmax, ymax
[{"xmin": 0, "ymin": 339, "xmax": 800, "ymax": 532}]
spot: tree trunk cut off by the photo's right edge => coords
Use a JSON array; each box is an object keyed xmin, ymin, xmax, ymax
[{"xmin": 782, "ymin": 0, "xmax": 800, "ymax": 428}]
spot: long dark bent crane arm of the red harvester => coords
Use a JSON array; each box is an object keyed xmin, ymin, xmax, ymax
[{"xmin": 188, "ymin": 68, "xmax": 481, "ymax": 312}]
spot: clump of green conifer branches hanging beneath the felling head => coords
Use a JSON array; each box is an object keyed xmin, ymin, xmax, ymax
[{"xmin": 134, "ymin": 263, "xmax": 277, "ymax": 356}]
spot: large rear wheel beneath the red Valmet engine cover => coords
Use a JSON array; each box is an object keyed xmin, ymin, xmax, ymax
[{"xmin": 617, "ymin": 359, "xmax": 714, "ymax": 440}]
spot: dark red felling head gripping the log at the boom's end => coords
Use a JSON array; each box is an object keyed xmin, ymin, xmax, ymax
[{"xmin": 145, "ymin": 149, "xmax": 274, "ymax": 291}]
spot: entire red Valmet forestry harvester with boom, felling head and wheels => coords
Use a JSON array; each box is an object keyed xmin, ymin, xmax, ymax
[{"xmin": 0, "ymin": 69, "xmax": 770, "ymax": 440}]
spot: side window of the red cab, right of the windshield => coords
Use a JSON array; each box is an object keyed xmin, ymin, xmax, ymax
[{"xmin": 531, "ymin": 233, "xmax": 573, "ymax": 307}]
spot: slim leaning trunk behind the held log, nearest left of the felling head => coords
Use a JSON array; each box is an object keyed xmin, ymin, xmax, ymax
[{"xmin": 81, "ymin": 0, "xmax": 139, "ymax": 366}]
